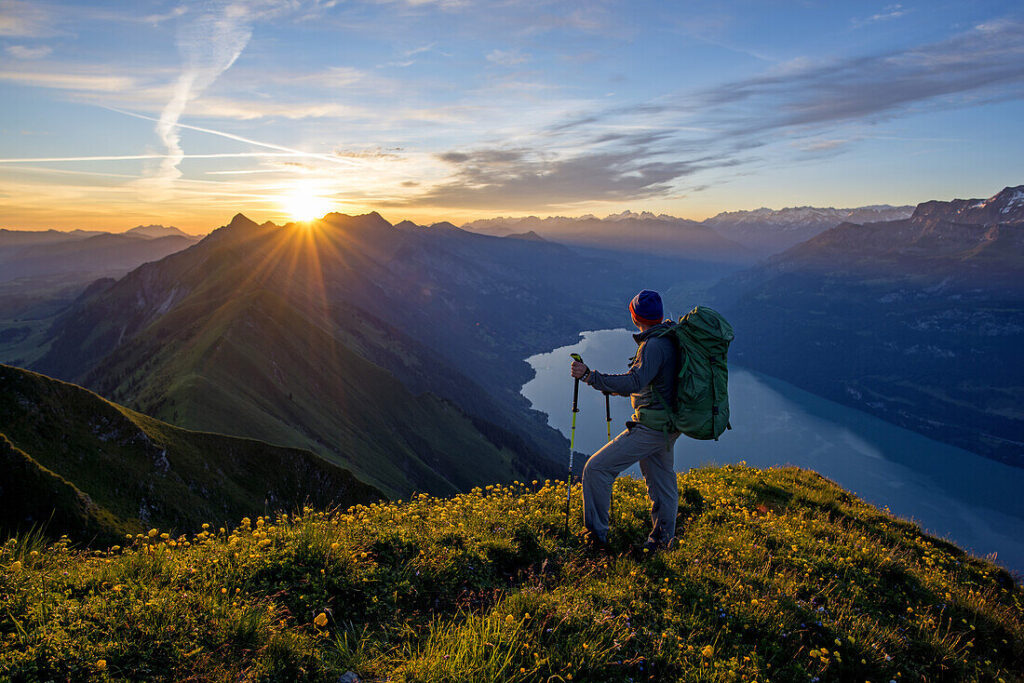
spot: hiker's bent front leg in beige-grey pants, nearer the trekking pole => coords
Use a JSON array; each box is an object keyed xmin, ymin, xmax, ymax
[{"xmin": 583, "ymin": 425, "xmax": 671, "ymax": 541}]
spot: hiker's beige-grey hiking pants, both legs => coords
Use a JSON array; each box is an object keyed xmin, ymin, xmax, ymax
[{"xmin": 583, "ymin": 424, "xmax": 679, "ymax": 545}]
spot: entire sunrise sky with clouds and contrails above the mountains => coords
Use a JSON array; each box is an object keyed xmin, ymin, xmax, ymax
[{"xmin": 0, "ymin": 0, "xmax": 1024, "ymax": 233}]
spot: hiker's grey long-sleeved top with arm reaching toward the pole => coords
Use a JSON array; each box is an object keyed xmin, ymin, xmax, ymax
[{"xmin": 586, "ymin": 323, "xmax": 679, "ymax": 420}]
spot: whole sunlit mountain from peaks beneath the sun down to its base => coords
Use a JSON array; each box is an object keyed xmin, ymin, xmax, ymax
[{"xmin": 29, "ymin": 217, "xmax": 552, "ymax": 496}]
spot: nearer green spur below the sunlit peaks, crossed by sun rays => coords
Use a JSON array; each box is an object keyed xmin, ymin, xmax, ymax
[{"xmin": 81, "ymin": 290, "xmax": 550, "ymax": 496}]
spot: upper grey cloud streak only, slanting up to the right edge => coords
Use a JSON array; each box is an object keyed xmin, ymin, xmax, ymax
[{"xmin": 549, "ymin": 20, "xmax": 1024, "ymax": 142}]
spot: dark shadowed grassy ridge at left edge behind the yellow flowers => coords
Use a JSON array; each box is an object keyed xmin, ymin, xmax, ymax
[{"xmin": 0, "ymin": 365, "xmax": 381, "ymax": 542}]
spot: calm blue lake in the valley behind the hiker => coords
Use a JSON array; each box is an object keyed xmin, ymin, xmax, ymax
[{"xmin": 522, "ymin": 330, "xmax": 1024, "ymax": 573}]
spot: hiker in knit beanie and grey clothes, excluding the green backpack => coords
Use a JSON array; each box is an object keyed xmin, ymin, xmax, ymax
[{"xmin": 569, "ymin": 290, "xmax": 680, "ymax": 552}]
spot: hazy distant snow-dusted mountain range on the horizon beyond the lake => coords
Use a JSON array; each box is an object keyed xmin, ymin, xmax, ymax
[{"xmin": 463, "ymin": 205, "xmax": 913, "ymax": 262}]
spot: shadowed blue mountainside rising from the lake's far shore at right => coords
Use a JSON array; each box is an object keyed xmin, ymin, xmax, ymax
[{"xmin": 720, "ymin": 186, "xmax": 1024, "ymax": 466}]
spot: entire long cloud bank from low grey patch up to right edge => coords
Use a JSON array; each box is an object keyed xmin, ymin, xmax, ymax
[{"xmin": 408, "ymin": 20, "xmax": 1024, "ymax": 209}]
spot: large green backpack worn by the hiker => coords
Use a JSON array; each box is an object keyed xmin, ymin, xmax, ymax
[{"xmin": 639, "ymin": 306, "xmax": 733, "ymax": 441}]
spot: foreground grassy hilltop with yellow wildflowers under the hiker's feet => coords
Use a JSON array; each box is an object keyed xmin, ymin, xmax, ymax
[{"xmin": 0, "ymin": 466, "xmax": 1024, "ymax": 682}]
